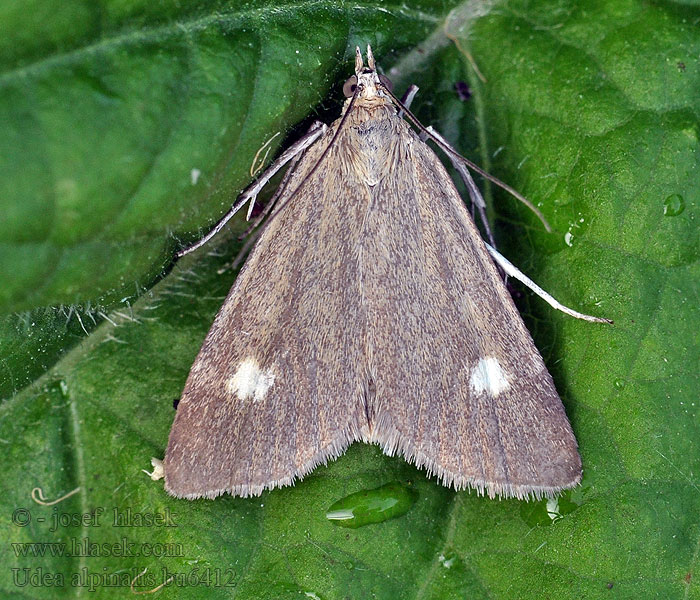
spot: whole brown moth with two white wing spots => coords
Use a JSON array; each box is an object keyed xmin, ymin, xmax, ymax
[{"xmin": 164, "ymin": 47, "xmax": 601, "ymax": 498}]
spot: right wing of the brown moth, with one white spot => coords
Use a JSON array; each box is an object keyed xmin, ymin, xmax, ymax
[{"xmin": 365, "ymin": 128, "xmax": 581, "ymax": 498}]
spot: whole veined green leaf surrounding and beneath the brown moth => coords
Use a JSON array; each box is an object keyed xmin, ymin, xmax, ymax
[{"xmin": 0, "ymin": 0, "xmax": 700, "ymax": 600}]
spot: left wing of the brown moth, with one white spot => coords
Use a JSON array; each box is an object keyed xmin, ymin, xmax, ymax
[{"xmin": 164, "ymin": 129, "xmax": 369, "ymax": 498}]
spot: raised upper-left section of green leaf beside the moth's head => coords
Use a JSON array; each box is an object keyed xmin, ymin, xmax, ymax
[{"xmin": 0, "ymin": 2, "xmax": 444, "ymax": 312}]
